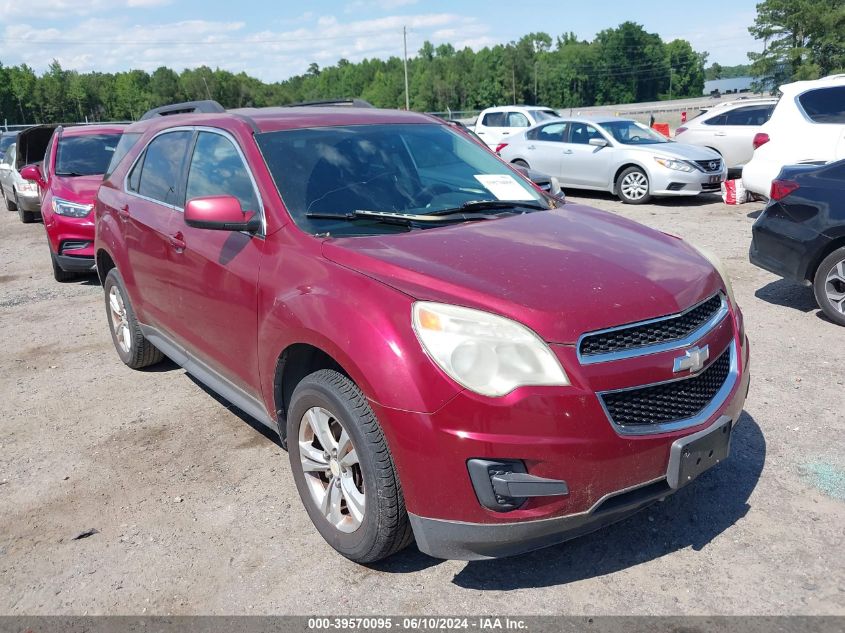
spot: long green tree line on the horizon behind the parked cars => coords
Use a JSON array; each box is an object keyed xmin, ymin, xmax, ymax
[{"xmin": 0, "ymin": 22, "xmax": 706, "ymax": 124}]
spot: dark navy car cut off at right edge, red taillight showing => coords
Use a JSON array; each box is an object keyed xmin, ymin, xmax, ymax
[{"xmin": 750, "ymin": 160, "xmax": 845, "ymax": 325}]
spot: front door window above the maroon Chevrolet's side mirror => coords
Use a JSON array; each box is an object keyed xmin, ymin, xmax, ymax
[{"xmin": 185, "ymin": 132, "xmax": 258, "ymax": 211}]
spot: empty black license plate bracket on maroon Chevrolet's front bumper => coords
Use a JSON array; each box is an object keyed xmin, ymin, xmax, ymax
[{"xmin": 666, "ymin": 416, "xmax": 733, "ymax": 489}]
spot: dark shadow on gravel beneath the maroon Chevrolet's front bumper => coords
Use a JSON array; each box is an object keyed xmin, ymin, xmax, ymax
[{"xmin": 373, "ymin": 412, "xmax": 766, "ymax": 591}]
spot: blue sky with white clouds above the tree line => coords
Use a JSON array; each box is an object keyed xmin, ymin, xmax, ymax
[{"xmin": 0, "ymin": 0, "xmax": 761, "ymax": 81}]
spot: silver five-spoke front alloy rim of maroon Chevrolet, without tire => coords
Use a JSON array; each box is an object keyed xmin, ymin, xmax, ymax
[{"xmin": 299, "ymin": 407, "xmax": 366, "ymax": 532}]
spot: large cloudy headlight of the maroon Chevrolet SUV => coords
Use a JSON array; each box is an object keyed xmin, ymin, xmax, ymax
[{"xmin": 413, "ymin": 301, "xmax": 569, "ymax": 396}]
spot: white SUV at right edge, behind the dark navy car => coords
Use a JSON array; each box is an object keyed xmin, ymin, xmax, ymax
[{"xmin": 742, "ymin": 75, "xmax": 845, "ymax": 196}]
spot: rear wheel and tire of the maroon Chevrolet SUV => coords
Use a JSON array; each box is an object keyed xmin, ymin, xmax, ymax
[{"xmin": 103, "ymin": 268, "xmax": 164, "ymax": 369}]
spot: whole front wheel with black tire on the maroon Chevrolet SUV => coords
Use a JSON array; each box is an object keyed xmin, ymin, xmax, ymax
[{"xmin": 287, "ymin": 369, "xmax": 413, "ymax": 563}]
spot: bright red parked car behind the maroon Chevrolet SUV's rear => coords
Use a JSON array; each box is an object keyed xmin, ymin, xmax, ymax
[{"xmin": 18, "ymin": 125, "xmax": 124, "ymax": 281}]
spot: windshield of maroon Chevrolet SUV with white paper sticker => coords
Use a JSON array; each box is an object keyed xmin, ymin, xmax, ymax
[{"xmin": 256, "ymin": 124, "xmax": 548, "ymax": 235}]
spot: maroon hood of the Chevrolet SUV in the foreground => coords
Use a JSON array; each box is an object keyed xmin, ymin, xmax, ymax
[{"xmin": 323, "ymin": 204, "xmax": 721, "ymax": 343}]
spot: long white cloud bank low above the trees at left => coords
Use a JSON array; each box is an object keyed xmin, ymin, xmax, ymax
[{"xmin": 0, "ymin": 12, "xmax": 492, "ymax": 81}]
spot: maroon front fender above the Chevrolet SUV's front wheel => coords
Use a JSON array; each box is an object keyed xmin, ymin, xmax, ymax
[{"xmin": 258, "ymin": 232, "xmax": 461, "ymax": 412}]
